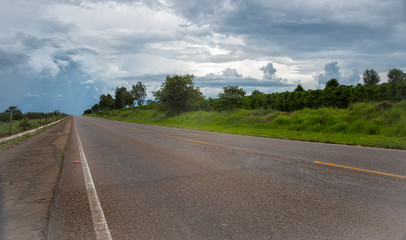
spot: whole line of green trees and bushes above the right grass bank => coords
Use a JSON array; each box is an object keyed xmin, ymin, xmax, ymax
[{"xmin": 84, "ymin": 69, "xmax": 406, "ymax": 115}]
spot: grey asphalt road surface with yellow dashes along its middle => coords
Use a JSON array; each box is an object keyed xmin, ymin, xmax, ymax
[{"xmin": 46, "ymin": 117, "xmax": 406, "ymax": 239}]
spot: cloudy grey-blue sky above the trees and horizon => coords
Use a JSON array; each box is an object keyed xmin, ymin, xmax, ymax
[{"xmin": 0, "ymin": 0, "xmax": 406, "ymax": 114}]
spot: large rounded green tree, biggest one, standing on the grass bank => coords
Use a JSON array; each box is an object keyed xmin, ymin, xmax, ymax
[{"xmin": 153, "ymin": 74, "xmax": 204, "ymax": 115}]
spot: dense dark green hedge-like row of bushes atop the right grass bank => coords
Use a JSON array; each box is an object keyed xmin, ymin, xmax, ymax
[{"xmin": 235, "ymin": 81, "xmax": 406, "ymax": 112}]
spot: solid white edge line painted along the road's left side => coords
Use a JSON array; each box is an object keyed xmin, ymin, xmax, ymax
[{"xmin": 75, "ymin": 123, "xmax": 112, "ymax": 240}]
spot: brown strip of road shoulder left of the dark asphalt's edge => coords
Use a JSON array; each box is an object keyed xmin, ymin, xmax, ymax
[{"xmin": 0, "ymin": 118, "xmax": 72, "ymax": 240}]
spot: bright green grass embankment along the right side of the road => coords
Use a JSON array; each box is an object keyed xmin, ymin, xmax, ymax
[{"xmin": 89, "ymin": 101, "xmax": 406, "ymax": 149}]
